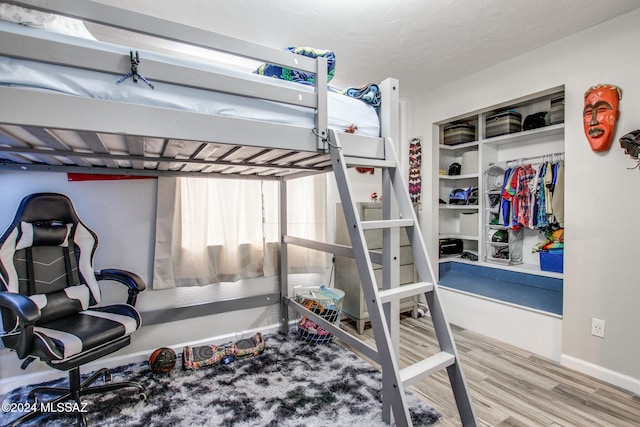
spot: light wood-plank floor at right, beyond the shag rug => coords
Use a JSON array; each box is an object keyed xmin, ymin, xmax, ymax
[{"xmin": 342, "ymin": 317, "xmax": 640, "ymax": 427}]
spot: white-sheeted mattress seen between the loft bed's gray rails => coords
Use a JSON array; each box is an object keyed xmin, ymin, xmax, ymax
[{"xmin": 0, "ymin": 21, "xmax": 380, "ymax": 136}]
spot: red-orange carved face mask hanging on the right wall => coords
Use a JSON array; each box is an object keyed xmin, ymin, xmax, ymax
[{"xmin": 582, "ymin": 84, "xmax": 622, "ymax": 152}]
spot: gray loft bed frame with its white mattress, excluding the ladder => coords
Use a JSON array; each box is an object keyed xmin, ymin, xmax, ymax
[{"xmin": 0, "ymin": 0, "xmax": 399, "ymax": 334}]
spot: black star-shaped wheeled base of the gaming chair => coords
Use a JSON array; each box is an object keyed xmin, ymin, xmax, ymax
[{"xmin": 8, "ymin": 367, "xmax": 146, "ymax": 427}]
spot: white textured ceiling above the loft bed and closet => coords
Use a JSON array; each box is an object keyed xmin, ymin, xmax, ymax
[{"xmin": 94, "ymin": 0, "xmax": 640, "ymax": 93}]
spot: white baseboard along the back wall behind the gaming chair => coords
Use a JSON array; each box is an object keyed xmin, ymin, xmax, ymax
[{"xmin": 0, "ymin": 324, "xmax": 280, "ymax": 401}]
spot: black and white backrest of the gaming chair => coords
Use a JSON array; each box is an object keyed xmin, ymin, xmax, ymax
[{"xmin": 0, "ymin": 193, "xmax": 100, "ymax": 330}]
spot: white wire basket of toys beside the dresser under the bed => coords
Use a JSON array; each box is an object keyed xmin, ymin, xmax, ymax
[{"xmin": 295, "ymin": 286, "xmax": 344, "ymax": 344}]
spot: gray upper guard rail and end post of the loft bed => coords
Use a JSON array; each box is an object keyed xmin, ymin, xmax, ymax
[{"xmin": 5, "ymin": 0, "xmax": 328, "ymax": 149}]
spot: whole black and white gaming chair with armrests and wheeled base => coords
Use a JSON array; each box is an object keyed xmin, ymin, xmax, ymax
[{"xmin": 0, "ymin": 193, "xmax": 145, "ymax": 425}]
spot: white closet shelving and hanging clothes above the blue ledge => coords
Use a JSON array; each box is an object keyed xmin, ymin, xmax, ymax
[{"xmin": 433, "ymin": 87, "xmax": 564, "ymax": 278}]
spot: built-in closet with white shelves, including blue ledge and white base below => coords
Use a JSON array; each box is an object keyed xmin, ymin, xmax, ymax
[{"xmin": 424, "ymin": 86, "xmax": 571, "ymax": 360}]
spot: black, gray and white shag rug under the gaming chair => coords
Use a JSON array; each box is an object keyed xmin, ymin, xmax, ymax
[{"xmin": 0, "ymin": 334, "xmax": 441, "ymax": 427}]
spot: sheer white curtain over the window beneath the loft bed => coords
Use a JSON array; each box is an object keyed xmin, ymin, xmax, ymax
[{"xmin": 153, "ymin": 175, "xmax": 327, "ymax": 289}]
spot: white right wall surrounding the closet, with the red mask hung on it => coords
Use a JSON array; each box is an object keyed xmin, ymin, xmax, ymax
[{"xmin": 412, "ymin": 11, "xmax": 640, "ymax": 392}]
